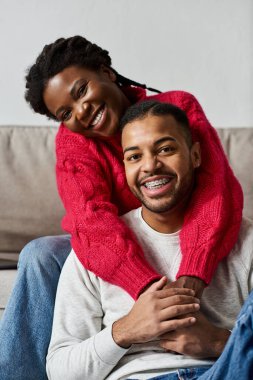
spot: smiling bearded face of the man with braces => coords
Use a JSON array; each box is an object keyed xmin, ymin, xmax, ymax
[{"xmin": 122, "ymin": 115, "xmax": 200, "ymax": 213}]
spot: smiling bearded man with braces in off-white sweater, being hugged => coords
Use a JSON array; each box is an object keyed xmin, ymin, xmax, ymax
[{"xmin": 47, "ymin": 101, "xmax": 253, "ymax": 380}]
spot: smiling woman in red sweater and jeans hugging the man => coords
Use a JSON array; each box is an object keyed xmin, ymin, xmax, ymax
[{"xmin": 0, "ymin": 36, "xmax": 242, "ymax": 380}]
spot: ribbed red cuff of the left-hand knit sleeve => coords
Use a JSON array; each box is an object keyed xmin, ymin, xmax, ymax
[{"xmin": 110, "ymin": 255, "xmax": 161, "ymax": 300}]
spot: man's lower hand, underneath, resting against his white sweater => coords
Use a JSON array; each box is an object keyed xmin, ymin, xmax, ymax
[{"xmin": 160, "ymin": 312, "xmax": 230, "ymax": 359}]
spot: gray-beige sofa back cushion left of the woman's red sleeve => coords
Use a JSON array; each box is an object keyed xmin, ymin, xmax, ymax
[{"xmin": 0, "ymin": 126, "xmax": 64, "ymax": 252}]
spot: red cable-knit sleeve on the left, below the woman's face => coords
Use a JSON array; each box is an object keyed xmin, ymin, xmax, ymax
[{"xmin": 56, "ymin": 131, "xmax": 160, "ymax": 299}]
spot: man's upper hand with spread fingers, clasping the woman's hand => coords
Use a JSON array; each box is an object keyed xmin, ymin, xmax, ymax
[{"xmin": 112, "ymin": 277, "xmax": 199, "ymax": 348}]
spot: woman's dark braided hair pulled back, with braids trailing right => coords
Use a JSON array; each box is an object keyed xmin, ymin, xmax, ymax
[{"xmin": 25, "ymin": 36, "xmax": 159, "ymax": 120}]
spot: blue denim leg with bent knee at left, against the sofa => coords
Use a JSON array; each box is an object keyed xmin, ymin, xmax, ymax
[{"xmin": 0, "ymin": 236, "xmax": 71, "ymax": 380}]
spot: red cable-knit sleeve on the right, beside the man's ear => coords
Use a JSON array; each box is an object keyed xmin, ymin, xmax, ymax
[{"xmin": 160, "ymin": 91, "xmax": 243, "ymax": 284}]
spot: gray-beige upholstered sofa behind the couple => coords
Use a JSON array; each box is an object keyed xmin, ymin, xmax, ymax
[{"xmin": 0, "ymin": 126, "xmax": 253, "ymax": 317}]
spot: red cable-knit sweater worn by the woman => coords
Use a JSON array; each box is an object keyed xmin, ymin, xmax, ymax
[{"xmin": 56, "ymin": 88, "xmax": 243, "ymax": 299}]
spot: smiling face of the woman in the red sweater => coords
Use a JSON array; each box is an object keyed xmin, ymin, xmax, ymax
[{"xmin": 43, "ymin": 66, "xmax": 130, "ymax": 138}]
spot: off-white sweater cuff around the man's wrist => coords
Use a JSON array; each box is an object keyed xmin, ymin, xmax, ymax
[{"xmin": 94, "ymin": 325, "xmax": 129, "ymax": 366}]
